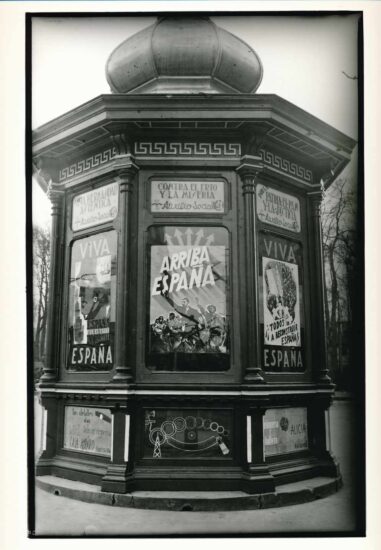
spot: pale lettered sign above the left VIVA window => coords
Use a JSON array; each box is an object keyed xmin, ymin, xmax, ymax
[{"xmin": 72, "ymin": 183, "xmax": 119, "ymax": 231}]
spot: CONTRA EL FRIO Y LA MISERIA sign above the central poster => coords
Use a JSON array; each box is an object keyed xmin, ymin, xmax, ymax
[{"xmin": 151, "ymin": 181, "xmax": 225, "ymax": 214}]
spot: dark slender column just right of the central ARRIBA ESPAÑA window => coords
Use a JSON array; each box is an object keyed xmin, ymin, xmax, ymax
[{"xmin": 237, "ymin": 163, "xmax": 264, "ymax": 384}]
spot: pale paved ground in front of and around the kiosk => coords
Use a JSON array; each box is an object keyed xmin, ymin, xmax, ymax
[{"xmin": 31, "ymin": 401, "xmax": 358, "ymax": 536}]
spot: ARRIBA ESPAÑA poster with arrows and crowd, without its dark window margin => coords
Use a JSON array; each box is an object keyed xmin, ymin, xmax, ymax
[{"xmin": 150, "ymin": 228, "xmax": 229, "ymax": 354}]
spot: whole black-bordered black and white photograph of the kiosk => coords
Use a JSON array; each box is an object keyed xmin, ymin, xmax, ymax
[{"xmin": 3, "ymin": 2, "xmax": 376, "ymax": 545}]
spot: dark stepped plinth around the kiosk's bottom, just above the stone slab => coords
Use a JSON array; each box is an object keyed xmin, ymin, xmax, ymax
[{"xmin": 36, "ymin": 455, "xmax": 340, "ymax": 495}]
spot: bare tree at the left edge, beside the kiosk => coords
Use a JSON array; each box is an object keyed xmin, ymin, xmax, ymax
[{"xmin": 33, "ymin": 226, "xmax": 50, "ymax": 361}]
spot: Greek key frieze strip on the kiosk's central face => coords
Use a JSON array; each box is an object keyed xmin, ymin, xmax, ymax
[{"xmin": 134, "ymin": 141, "xmax": 241, "ymax": 157}]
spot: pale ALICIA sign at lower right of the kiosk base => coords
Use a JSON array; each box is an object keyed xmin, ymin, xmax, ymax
[{"xmin": 263, "ymin": 407, "xmax": 308, "ymax": 457}]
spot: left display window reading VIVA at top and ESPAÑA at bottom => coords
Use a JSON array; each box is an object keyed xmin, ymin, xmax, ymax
[{"xmin": 68, "ymin": 231, "xmax": 116, "ymax": 370}]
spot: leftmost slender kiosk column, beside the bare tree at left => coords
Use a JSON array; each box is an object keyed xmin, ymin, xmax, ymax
[{"xmin": 41, "ymin": 182, "xmax": 64, "ymax": 385}]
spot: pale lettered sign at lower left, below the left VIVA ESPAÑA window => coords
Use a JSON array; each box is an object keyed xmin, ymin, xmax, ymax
[{"xmin": 64, "ymin": 406, "xmax": 112, "ymax": 456}]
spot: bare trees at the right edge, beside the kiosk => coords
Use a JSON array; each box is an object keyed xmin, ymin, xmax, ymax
[{"xmin": 322, "ymin": 178, "xmax": 357, "ymax": 387}]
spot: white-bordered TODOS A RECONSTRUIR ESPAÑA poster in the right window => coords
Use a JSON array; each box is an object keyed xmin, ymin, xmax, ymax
[{"xmin": 262, "ymin": 257, "xmax": 301, "ymax": 347}]
